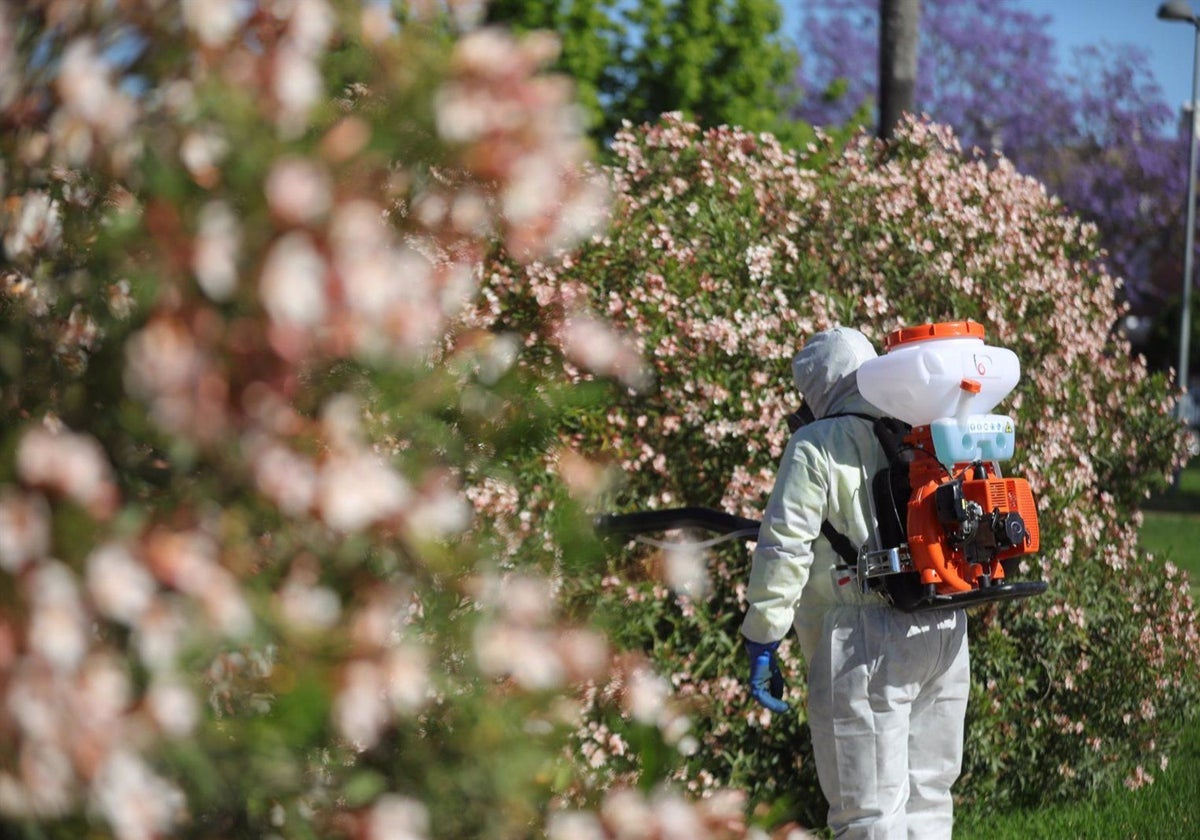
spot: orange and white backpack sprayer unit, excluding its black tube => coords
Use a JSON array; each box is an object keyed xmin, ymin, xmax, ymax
[{"xmin": 858, "ymin": 320, "xmax": 1045, "ymax": 608}]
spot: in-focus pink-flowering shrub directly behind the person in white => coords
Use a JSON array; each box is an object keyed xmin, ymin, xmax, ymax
[{"xmin": 468, "ymin": 115, "xmax": 1200, "ymax": 824}]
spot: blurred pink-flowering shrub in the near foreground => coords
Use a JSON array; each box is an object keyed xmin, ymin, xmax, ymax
[{"xmin": 0, "ymin": 0, "xmax": 777, "ymax": 840}]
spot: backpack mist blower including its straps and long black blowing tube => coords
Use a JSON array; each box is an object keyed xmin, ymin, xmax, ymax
[{"xmin": 595, "ymin": 320, "xmax": 1046, "ymax": 612}]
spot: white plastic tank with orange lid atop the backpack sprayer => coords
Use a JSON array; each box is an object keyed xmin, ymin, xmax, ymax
[{"xmin": 858, "ymin": 320, "xmax": 1021, "ymax": 426}]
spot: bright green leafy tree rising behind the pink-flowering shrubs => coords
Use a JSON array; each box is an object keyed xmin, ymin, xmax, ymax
[{"xmin": 488, "ymin": 0, "xmax": 798, "ymax": 142}]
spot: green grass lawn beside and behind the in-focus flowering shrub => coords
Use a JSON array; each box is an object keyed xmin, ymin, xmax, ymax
[{"xmin": 954, "ymin": 460, "xmax": 1200, "ymax": 840}]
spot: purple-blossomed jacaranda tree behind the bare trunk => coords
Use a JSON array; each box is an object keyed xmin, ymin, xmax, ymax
[{"xmin": 797, "ymin": 0, "xmax": 1187, "ymax": 311}]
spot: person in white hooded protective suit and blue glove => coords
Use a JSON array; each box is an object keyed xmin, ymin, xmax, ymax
[{"xmin": 742, "ymin": 328, "xmax": 970, "ymax": 840}]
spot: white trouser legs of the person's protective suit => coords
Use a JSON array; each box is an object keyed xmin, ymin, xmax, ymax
[{"xmin": 809, "ymin": 606, "xmax": 970, "ymax": 840}]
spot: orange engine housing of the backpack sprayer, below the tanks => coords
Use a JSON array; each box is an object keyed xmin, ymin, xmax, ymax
[{"xmin": 907, "ymin": 426, "xmax": 1039, "ymax": 594}]
